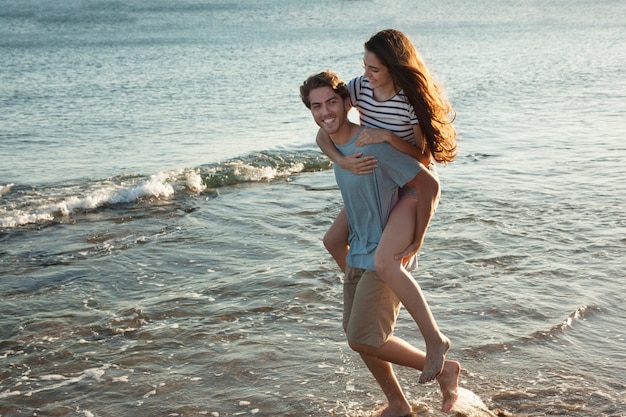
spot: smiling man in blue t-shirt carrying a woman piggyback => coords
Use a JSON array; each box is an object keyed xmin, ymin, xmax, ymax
[{"xmin": 300, "ymin": 71, "xmax": 460, "ymax": 417}]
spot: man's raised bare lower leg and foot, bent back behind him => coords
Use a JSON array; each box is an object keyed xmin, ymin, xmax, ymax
[{"xmin": 350, "ymin": 336, "xmax": 461, "ymax": 412}]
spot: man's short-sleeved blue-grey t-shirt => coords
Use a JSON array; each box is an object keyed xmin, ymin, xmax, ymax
[{"xmin": 334, "ymin": 128, "xmax": 422, "ymax": 271}]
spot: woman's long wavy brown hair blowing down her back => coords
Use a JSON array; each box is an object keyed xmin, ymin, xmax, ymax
[{"xmin": 365, "ymin": 29, "xmax": 457, "ymax": 164}]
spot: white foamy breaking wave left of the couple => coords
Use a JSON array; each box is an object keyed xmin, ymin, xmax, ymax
[{"xmin": 0, "ymin": 151, "xmax": 331, "ymax": 229}]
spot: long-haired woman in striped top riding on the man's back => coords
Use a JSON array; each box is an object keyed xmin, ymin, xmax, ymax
[{"xmin": 317, "ymin": 29, "xmax": 457, "ymax": 383}]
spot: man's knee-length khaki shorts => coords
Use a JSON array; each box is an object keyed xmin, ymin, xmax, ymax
[{"xmin": 343, "ymin": 266, "xmax": 400, "ymax": 347}]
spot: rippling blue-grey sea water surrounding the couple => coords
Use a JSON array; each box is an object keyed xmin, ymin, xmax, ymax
[{"xmin": 0, "ymin": 0, "xmax": 626, "ymax": 417}]
